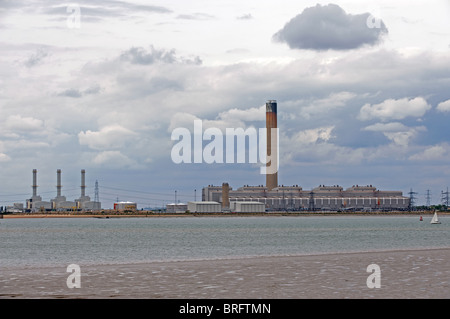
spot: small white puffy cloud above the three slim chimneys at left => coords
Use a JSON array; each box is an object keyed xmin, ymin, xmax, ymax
[{"xmin": 78, "ymin": 125, "xmax": 137, "ymax": 150}]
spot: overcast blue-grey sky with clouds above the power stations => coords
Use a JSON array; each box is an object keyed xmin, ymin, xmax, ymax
[{"xmin": 0, "ymin": 0, "xmax": 450, "ymax": 208}]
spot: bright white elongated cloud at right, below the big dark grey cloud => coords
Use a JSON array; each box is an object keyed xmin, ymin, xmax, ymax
[{"xmin": 358, "ymin": 97, "xmax": 431, "ymax": 121}]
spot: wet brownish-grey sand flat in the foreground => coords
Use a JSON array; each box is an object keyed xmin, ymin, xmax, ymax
[{"xmin": 0, "ymin": 248, "xmax": 450, "ymax": 299}]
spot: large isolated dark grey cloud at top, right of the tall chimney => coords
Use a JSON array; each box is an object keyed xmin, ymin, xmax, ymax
[{"xmin": 273, "ymin": 4, "xmax": 388, "ymax": 50}]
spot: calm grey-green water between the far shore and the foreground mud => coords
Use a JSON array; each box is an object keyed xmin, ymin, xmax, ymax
[{"xmin": 0, "ymin": 216, "xmax": 450, "ymax": 268}]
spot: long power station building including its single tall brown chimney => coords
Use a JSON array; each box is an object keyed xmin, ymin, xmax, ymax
[{"xmin": 202, "ymin": 100, "xmax": 410, "ymax": 211}]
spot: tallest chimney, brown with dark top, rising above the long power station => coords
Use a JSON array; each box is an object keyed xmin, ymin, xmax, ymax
[{"xmin": 266, "ymin": 100, "xmax": 278, "ymax": 191}]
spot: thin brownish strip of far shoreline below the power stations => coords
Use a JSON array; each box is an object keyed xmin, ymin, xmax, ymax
[{"xmin": 0, "ymin": 211, "xmax": 450, "ymax": 219}]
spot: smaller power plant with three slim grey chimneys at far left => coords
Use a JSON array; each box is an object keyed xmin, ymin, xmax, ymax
[{"xmin": 26, "ymin": 169, "xmax": 101, "ymax": 212}]
